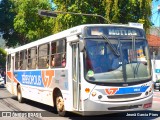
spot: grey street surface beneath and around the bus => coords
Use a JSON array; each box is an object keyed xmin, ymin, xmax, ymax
[{"xmin": 0, "ymin": 86, "xmax": 160, "ymax": 120}]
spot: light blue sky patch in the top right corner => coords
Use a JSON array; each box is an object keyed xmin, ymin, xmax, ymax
[{"xmin": 151, "ymin": 0, "xmax": 160, "ymax": 27}]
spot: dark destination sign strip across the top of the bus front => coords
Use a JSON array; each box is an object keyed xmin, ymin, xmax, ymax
[{"xmin": 86, "ymin": 26, "xmax": 145, "ymax": 37}]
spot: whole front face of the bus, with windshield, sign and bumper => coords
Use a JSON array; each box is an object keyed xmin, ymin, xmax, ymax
[{"xmin": 79, "ymin": 26, "xmax": 153, "ymax": 114}]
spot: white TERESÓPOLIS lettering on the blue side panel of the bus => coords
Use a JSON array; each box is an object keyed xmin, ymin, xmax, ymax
[{"xmin": 22, "ymin": 75, "xmax": 42, "ymax": 86}]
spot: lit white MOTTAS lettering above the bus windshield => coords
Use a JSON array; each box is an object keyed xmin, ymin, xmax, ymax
[{"xmin": 109, "ymin": 29, "xmax": 137, "ymax": 35}]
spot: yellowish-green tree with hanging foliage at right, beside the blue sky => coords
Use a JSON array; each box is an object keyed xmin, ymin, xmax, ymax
[{"xmin": 103, "ymin": 0, "xmax": 152, "ymax": 30}]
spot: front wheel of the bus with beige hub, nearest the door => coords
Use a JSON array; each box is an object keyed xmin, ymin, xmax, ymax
[{"xmin": 56, "ymin": 92, "xmax": 67, "ymax": 117}]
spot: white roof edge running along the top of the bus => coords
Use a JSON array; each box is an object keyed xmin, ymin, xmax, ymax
[{"xmin": 8, "ymin": 24, "xmax": 143, "ymax": 53}]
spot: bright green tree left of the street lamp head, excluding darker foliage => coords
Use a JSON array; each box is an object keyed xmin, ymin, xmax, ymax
[{"xmin": 14, "ymin": 0, "xmax": 54, "ymax": 44}]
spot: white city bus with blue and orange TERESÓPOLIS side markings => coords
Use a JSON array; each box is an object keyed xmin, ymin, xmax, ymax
[{"xmin": 6, "ymin": 24, "xmax": 153, "ymax": 116}]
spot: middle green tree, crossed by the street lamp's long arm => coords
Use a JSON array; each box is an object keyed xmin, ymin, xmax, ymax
[{"xmin": 54, "ymin": 0, "xmax": 105, "ymax": 32}]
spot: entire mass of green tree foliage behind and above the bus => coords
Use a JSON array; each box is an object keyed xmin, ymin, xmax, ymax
[{"xmin": 0, "ymin": 0, "xmax": 152, "ymax": 46}]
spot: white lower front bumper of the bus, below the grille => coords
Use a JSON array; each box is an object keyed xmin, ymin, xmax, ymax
[{"xmin": 82, "ymin": 95, "xmax": 153, "ymax": 115}]
